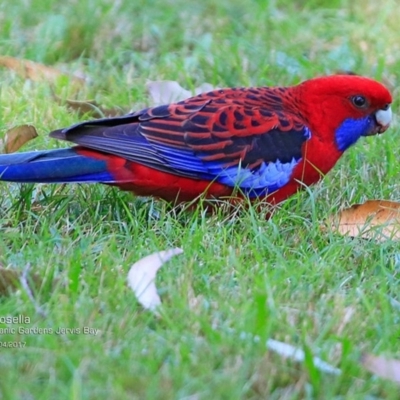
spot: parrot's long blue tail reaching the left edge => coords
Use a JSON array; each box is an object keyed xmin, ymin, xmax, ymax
[{"xmin": 0, "ymin": 147, "xmax": 115, "ymax": 184}]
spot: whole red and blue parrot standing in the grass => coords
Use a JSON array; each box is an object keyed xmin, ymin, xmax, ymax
[{"xmin": 0, "ymin": 75, "xmax": 392, "ymax": 204}]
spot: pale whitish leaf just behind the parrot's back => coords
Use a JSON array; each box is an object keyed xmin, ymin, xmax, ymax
[{"xmin": 146, "ymin": 81, "xmax": 218, "ymax": 105}]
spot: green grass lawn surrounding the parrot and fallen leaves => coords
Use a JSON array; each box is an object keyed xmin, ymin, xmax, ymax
[{"xmin": 0, "ymin": 0, "xmax": 400, "ymax": 399}]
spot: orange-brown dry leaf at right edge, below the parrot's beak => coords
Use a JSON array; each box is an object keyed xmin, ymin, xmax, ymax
[{"xmin": 328, "ymin": 200, "xmax": 400, "ymax": 241}]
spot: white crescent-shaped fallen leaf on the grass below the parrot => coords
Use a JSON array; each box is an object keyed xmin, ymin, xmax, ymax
[{"xmin": 128, "ymin": 247, "xmax": 183, "ymax": 311}]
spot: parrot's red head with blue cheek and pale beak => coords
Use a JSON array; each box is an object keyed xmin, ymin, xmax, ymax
[{"xmin": 295, "ymin": 75, "xmax": 392, "ymax": 151}]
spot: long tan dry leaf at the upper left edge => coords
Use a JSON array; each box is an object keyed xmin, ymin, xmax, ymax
[{"xmin": 0, "ymin": 56, "xmax": 85, "ymax": 86}]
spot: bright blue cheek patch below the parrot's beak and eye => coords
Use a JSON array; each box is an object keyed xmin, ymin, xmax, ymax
[{"xmin": 335, "ymin": 116, "xmax": 374, "ymax": 151}]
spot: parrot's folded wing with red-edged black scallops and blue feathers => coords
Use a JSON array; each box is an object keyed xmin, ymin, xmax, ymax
[{"xmin": 51, "ymin": 96, "xmax": 311, "ymax": 191}]
